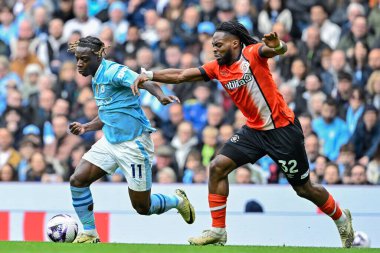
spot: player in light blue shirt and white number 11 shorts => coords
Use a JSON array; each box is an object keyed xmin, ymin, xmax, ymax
[{"xmin": 68, "ymin": 36, "xmax": 195, "ymax": 243}]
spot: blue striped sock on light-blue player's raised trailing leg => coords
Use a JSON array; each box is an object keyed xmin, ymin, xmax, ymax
[{"xmin": 148, "ymin": 194, "xmax": 179, "ymax": 215}]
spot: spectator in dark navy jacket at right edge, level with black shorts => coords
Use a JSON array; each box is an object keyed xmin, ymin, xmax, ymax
[{"xmin": 350, "ymin": 105, "xmax": 380, "ymax": 166}]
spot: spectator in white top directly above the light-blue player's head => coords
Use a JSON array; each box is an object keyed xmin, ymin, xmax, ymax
[{"xmin": 63, "ymin": 0, "xmax": 101, "ymax": 41}]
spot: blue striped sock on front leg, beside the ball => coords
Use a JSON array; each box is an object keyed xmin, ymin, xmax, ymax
[{"xmin": 70, "ymin": 186, "xmax": 95, "ymax": 230}]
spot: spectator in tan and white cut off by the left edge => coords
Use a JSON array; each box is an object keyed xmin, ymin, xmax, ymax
[{"xmin": 0, "ymin": 128, "xmax": 21, "ymax": 168}]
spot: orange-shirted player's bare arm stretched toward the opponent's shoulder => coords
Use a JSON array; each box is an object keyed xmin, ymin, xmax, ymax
[{"xmin": 131, "ymin": 68, "xmax": 203, "ymax": 94}]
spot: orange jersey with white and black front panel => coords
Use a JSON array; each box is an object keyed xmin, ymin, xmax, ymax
[{"xmin": 199, "ymin": 43, "xmax": 294, "ymax": 130}]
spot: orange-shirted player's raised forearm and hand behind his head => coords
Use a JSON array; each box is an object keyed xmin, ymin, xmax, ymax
[{"xmin": 260, "ymin": 32, "xmax": 288, "ymax": 58}]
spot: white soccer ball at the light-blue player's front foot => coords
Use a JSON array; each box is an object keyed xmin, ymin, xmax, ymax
[{"xmin": 47, "ymin": 214, "xmax": 78, "ymax": 242}]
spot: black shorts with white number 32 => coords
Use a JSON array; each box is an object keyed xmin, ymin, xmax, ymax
[{"xmin": 219, "ymin": 118, "xmax": 309, "ymax": 185}]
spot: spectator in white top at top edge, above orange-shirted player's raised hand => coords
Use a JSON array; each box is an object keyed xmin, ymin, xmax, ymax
[{"xmin": 257, "ymin": 0, "xmax": 293, "ymax": 34}]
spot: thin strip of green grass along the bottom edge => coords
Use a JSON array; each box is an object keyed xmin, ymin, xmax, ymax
[{"xmin": 0, "ymin": 242, "xmax": 379, "ymax": 253}]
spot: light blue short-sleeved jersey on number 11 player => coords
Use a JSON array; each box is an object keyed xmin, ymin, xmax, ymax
[{"xmin": 92, "ymin": 59, "xmax": 155, "ymax": 144}]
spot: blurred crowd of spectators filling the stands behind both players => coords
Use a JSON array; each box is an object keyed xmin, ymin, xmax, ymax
[{"xmin": 0, "ymin": 0, "xmax": 380, "ymax": 185}]
